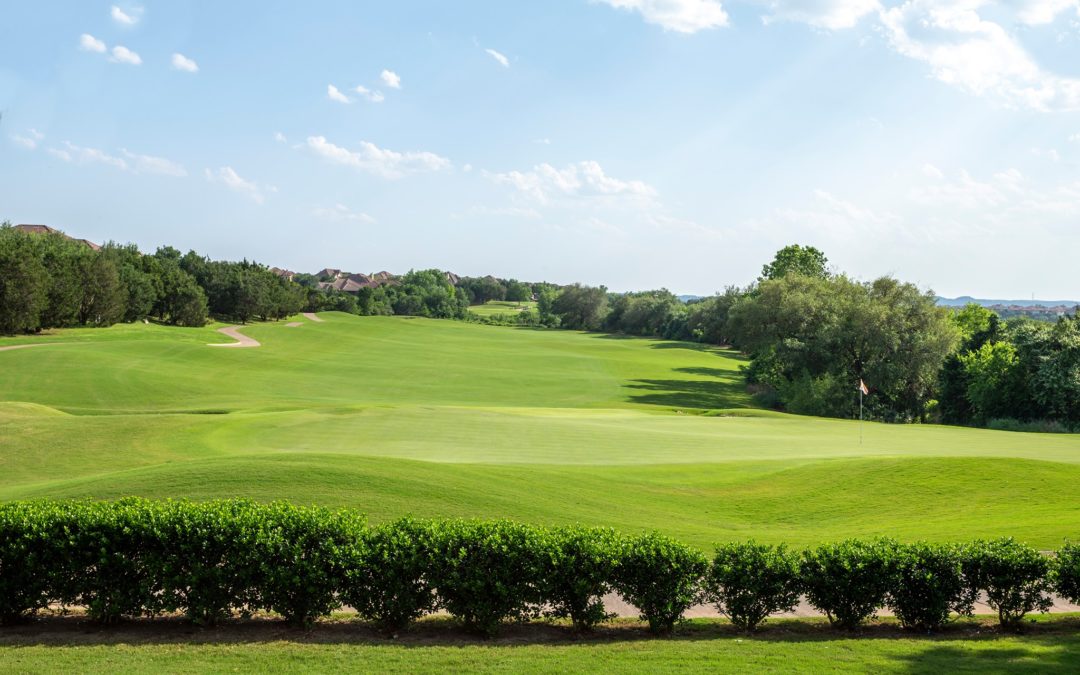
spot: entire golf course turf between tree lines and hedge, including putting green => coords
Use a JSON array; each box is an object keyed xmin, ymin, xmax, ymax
[{"xmin": 0, "ymin": 313, "xmax": 1080, "ymax": 548}]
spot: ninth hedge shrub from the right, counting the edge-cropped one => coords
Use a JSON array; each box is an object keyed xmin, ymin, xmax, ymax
[{"xmin": 341, "ymin": 518, "xmax": 436, "ymax": 633}]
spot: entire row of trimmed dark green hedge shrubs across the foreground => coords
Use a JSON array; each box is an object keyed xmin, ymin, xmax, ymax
[{"xmin": 0, "ymin": 499, "xmax": 1080, "ymax": 635}]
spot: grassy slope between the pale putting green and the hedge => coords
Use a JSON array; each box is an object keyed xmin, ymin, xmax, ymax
[{"xmin": 0, "ymin": 453, "xmax": 1080, "ymax": 550}]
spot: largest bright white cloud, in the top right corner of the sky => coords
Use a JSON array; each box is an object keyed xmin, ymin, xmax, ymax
[{"xmin": 880, "ymin": 0, "xmax": 1080, "ymax": 110}]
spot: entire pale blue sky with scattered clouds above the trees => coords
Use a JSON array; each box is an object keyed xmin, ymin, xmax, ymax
[{"xmin": 0, "ymin": 0, "xmax": 1080, "ymax": 299}]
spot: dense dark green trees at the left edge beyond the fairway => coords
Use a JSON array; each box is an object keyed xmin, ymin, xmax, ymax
[{"xmin": 0, "ymin": 224, "xmax": 305, "ymax": 334}]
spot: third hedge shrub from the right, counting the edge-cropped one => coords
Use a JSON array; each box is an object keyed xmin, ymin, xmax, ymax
[{"xmin": 888, "ymin": 542, "xmax": 975, "ymax": 631}]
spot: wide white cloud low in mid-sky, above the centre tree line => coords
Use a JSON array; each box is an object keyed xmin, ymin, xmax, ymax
[{"xmin": 485, "ymin": 161, "xmax": 657, "ymax": 204}]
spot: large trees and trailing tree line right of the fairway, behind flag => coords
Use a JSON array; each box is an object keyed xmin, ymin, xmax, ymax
[{"xmin": 531, "ymin": 245, "xmax": 1080, "ymax": 431}]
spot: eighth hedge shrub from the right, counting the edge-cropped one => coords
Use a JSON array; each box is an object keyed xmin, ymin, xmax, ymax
[{"xmin": 432, "ymin": 521, "xmax": 543, "ymax": 637}]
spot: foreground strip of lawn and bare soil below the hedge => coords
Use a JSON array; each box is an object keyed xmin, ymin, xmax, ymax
[{"xmin": 0, "ymin": 618, "xmax": 1080, "ymax": 673}]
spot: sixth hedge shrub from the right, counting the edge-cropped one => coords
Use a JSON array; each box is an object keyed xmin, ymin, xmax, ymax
[{"xmin": 615, "ymin": 532, "xmax": 708, "ymax": 633}]
